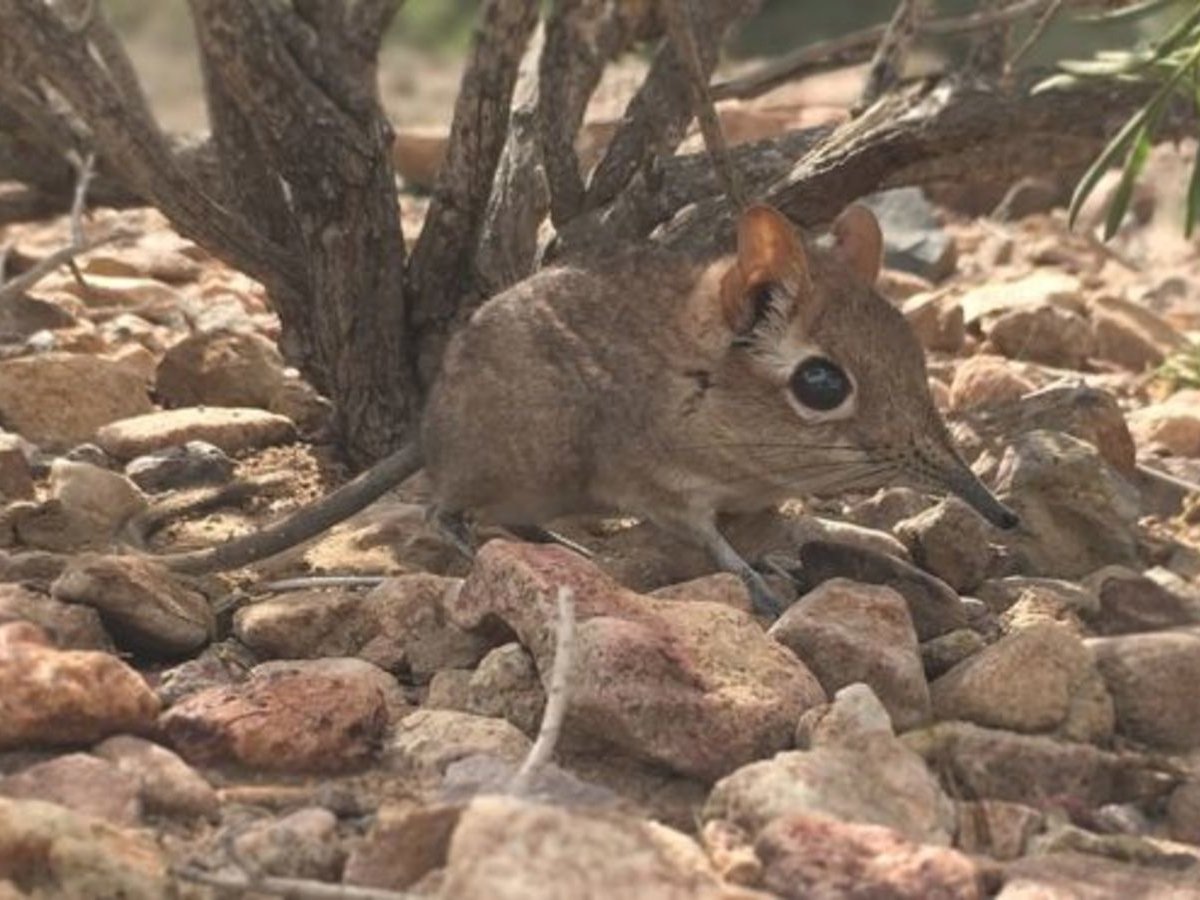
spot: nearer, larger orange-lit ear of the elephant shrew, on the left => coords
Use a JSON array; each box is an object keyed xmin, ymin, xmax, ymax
[{"xmin": 721, "ymin": 206, "xmax": 810, "ymax": 335}]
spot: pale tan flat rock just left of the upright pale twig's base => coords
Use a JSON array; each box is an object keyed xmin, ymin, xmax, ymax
[{"xmin": 384, "ymin": 709, "xmax": 532, "ymax": 776}]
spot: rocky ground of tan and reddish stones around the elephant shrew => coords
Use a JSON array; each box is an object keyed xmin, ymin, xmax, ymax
[{"xmin": 0, "ymin": 98, "xmax": 1200, "ymax": 900}]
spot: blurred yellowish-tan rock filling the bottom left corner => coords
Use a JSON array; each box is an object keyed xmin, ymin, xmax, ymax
[{"xmin": 0, "ymin": 798, "xmax": 173, "ymax": 900}]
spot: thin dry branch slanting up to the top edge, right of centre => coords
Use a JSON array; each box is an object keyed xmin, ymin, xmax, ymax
[{"xmin": 710, "ymin": 0, "xmax": 1065, "ymax": 100}]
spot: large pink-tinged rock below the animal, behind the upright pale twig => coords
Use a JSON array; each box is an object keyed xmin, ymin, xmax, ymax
[{"xmin": 448, "ymin": 541, "xmax": 824, "ymax": 779}]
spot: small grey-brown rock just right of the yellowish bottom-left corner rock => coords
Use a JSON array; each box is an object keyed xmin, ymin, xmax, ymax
[{"xmin": 233, "ymin": 806, "xmax": 346, "ymax": 881}]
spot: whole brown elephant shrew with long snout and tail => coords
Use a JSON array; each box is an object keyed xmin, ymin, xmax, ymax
[{"xmin": 167, "ymin": 205, "xmax": 1016, "ymax": 612}]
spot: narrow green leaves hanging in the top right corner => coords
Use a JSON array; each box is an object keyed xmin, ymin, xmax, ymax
[{"xmin": 1034, "ymin": 0, "xmax": 1200, "ymax": 240}]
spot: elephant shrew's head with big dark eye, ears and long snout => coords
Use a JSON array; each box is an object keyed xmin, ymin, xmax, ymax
[{"xmin": 709, "ymin": 206, "xmax": 1016, "ymax": 528}]
